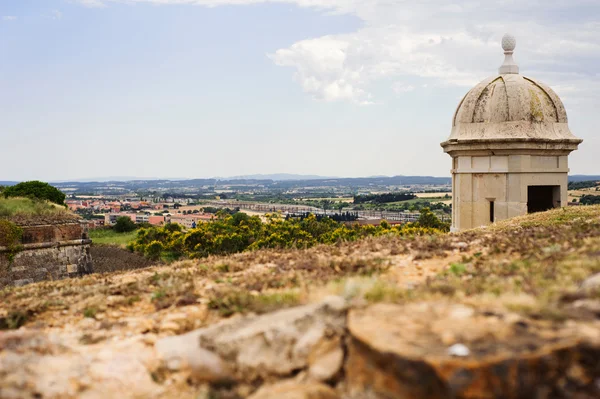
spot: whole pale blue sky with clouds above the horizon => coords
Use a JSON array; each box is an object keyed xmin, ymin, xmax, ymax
[{"xmin": 0, "ymin": 0, "xmax": 600, "ymax": 180}]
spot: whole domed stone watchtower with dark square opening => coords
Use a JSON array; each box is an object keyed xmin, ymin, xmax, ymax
[{"xmin": 441, "ymin": 35, "xmax": 582, "ymax": 231}]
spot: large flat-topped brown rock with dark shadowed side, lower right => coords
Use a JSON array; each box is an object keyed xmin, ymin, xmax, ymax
[{"xmin": 346, "ymin": 303, "xmax": 600, "ymax": 399}]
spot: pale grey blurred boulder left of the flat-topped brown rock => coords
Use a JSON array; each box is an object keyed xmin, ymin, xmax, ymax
[{"xmin": 155, "ymin": 297, "xmax": 347, "ymax": 382}]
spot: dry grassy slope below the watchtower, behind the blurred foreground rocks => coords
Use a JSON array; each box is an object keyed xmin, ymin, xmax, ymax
[{"xmin": 0, "ymin": 206, "xmax": 600, "ymax": 327}]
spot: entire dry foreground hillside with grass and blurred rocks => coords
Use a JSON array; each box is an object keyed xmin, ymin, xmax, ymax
[{"xmin": 0, "ymin": 207, "xmax": 600, "ymax": 399}]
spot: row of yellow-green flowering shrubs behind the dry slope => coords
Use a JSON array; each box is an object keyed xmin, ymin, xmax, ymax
[{"xmin": 127, "ymin": 211, "xmax": 448, "ymax": 259}]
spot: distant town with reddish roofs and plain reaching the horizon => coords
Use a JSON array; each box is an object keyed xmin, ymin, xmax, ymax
[{"xmin": 43, "ymin": 176, "xmax": 600, "ymax": 228}]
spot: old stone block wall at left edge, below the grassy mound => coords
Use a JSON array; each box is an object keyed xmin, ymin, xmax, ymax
[{"xmin": 0, "ymin": 220, "xmax": 93, "ymax": 288}]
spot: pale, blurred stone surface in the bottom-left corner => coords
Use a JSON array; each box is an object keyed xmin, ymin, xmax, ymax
[{"xmin": 0, "ymin": 331, "xmax": 162, "ymax": 399}]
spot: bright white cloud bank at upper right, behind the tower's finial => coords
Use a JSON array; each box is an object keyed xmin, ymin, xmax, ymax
[{"xmin": 71, "ymin": 0, "xmax": 600, "ymax": 104}]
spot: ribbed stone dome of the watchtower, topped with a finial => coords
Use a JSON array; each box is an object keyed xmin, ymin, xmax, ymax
[{"xmin": 442, "ymin": 35, "xmax": 582, "ymax": 150}]
